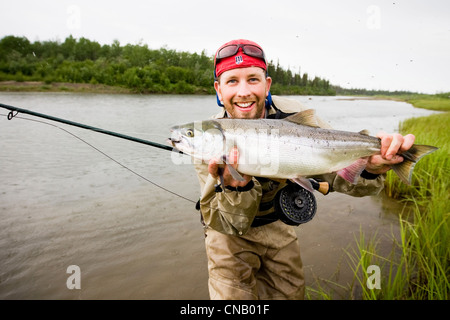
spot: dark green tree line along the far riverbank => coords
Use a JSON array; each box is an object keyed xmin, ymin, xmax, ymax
[{"xmin": 0, "ymin": 36, "xmax": 336, "ymax": 95}]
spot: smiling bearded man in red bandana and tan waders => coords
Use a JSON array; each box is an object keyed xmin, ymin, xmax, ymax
[{"xmin": 196, "ymin": 40, "xmax": 414, "ymax": 299}]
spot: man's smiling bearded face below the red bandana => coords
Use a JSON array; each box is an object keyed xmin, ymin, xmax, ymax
[{"xmin": 214, "ymin": 67, "xmax": 272, "ymax": 119}]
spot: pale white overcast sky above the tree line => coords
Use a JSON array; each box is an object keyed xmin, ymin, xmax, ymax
[{"xmin": 0, "ymin": 0, "xmax": 450, "ymax": 93}]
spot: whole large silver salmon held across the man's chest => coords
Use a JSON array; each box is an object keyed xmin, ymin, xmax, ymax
[{"xmin": 169, "ymin": 109, "xmax": 437, "ymax": 190}]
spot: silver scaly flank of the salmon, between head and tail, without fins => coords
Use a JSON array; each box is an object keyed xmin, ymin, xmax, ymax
[{"xmin": 214, "ymin": 119, "xmax": 380, "ymax": 179}]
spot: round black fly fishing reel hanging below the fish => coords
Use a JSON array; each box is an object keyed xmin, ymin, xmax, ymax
[{"xmin": 274, "ymin": 183, "xmax": 317, "ymax": 226}]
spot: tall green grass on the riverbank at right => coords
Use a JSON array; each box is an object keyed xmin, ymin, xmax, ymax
[{"xmin": 348, "ymin": 95, "xmax": 450, "ymax": 300}]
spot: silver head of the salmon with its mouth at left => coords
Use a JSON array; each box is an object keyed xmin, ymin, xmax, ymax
[{"xmin": 168, "ymin": 120, "xmax": 224, "ymax": 161}]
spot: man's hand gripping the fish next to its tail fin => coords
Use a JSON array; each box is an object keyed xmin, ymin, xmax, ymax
[{"xmin": 366, "ymin": 132, "xmax": 416, "ymax": 174}]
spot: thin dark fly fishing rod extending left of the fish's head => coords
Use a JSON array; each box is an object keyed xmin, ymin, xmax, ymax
[{"xmin": 0, "ymin": 103, "xmax": 183, "ymax": 154}]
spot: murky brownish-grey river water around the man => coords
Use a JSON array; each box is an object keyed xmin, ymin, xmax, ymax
[{"xmin": 0, "ymin": 93, "xmax": 432, "ymax": 299}]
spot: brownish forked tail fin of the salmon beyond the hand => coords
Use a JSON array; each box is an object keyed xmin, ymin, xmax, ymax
[{"xmin": 392, "ymin": 144, "xmax": 438, "ymax": 185}]
